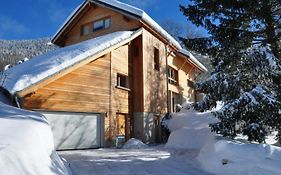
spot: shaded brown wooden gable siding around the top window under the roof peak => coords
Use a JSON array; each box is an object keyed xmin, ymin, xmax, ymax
[{"xmin": 60, "ymin": 5, "xmax": 141, "ymax": 46}]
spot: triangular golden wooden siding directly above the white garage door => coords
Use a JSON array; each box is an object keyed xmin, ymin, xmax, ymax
[{"xmin": 23, "ymin": 54, "xmax": 110, "ymax": 113}]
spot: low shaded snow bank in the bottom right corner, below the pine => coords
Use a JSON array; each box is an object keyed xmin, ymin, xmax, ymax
[{"xmin": 197, "ymin": 140, "xmax": 281, "ymax": 175}]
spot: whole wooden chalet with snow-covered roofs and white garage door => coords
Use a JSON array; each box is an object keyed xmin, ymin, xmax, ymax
[{"xmin": 4, "ymin": 0, "xmax": 206, "ymax": 149}]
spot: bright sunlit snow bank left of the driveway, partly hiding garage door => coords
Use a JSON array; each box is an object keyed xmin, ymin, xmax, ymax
[{"xmin": 0, "ymin": 102, "xmax": 69, "ymax": 175}]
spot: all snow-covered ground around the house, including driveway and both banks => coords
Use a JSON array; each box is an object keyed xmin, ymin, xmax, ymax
[{"xmin": 0, "ymin": 90, "xmax": 281, "ymax": 175}]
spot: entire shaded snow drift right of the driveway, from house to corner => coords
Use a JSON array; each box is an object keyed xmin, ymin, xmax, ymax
[{"xmin": 166, "ymin": 106, "xmax": 281, "ymax": 175}]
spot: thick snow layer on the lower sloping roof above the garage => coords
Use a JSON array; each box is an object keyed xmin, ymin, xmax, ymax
[{"xmin": 3, "ymin": 30, "xmax": 137, "ymax": 94}]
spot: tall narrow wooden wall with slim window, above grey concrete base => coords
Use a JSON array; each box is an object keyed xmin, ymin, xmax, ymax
[{"xmin": 143, "ymin": 30, "xmax": 167, "ymax": 113}]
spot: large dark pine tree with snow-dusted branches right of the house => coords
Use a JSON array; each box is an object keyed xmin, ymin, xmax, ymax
[{"xmin": 180, "ymin": 0, "xmax": 281, "ymax": 142}]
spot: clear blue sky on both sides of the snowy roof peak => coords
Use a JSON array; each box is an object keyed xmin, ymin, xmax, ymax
[{"xmin": 0, "ymin": 0, "xmax": 196, "ymax": 40}]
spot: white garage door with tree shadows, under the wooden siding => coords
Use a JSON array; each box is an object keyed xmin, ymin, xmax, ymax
[{"xmin": 41, "ymin": 112, "xmax": 104, "ymax": 150}]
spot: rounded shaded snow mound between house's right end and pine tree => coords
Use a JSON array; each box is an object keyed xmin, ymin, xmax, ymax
[{"xmin": 166, "ymin": 109, "xmax": 218, "ymax": 149}]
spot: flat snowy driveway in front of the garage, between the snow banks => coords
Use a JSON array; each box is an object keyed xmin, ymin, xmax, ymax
[{"xmin": 59, "ymin": 146, "xmax": 210, "ymax": 175}]
